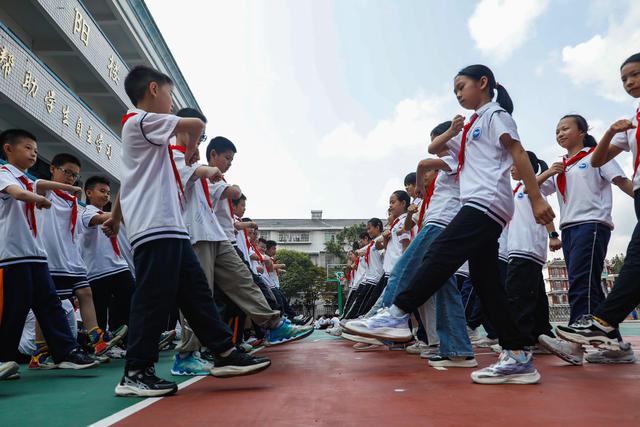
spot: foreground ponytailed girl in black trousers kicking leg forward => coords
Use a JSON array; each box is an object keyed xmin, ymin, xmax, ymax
[{"xmin": 344, "ymin": 65, "xmax": 554, "ymax": 384}]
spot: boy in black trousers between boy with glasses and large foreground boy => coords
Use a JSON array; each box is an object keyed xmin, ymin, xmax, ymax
[{"xmin": 79, "ymin": 176, "xmax": 135, "ymax": 357}]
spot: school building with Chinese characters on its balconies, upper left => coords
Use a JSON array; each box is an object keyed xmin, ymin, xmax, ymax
[{"xmin": 0, "ymin": 0, "xmax": 198, "ymax": 191}]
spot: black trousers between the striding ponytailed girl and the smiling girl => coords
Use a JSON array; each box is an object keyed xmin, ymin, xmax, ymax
[{"xmin": 506, "ymin": 257, "xmax": 555, "ymax": 345}]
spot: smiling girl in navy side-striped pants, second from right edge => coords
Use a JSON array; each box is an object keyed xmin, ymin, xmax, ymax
[{"xmin": 538, "ymin": 114, "xmax": 633, "ymax": 365}]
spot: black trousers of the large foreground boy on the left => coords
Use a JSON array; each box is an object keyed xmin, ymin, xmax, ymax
[{"xmin": 125, "ymin": 239, "xmax": 233, "ymax": 369}]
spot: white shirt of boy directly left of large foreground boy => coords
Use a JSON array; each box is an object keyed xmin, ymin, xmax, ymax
[{"xmin": 78, "ymin": 205, "xmax": 129, "ymax": 280}]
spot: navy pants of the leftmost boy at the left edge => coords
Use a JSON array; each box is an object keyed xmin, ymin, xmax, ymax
[{"xmin": 0, "ymin": 262, "xmax": 78, "ymax": 363}]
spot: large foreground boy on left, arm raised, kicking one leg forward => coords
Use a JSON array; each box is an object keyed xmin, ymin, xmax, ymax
[{"xmin": 102, "ymin": 66, "xmax": 271, "ymax": 396}]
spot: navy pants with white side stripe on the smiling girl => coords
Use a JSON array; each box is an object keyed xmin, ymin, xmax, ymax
[{"xmin": 562, "ymin": 222, "xmax": 611, "ymax": 324}]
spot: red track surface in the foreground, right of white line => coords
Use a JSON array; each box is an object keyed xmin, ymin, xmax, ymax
[{"xmin": 119, "ymin": 337, "xmax": 640, "ymax": 427}]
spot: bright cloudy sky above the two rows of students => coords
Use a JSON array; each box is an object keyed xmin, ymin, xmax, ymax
[{"xmin": 146, "ymin": 0, "xmax": 640, "ymax": 256}]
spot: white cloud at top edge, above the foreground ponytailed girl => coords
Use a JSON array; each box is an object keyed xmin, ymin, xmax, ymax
[{"xmin": 468, "ymin": 0, "xmax": 549, "ymax": 61}]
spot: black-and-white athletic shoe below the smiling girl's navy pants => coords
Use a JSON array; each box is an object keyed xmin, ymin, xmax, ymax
[{"xmin": 556, "ymin": 314, "xmax": 620, "ymax": 350}]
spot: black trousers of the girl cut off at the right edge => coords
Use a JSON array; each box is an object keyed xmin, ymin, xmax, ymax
[{"xmin": 593, "ymin": 190, "xmax": 640, "ymax": 327}]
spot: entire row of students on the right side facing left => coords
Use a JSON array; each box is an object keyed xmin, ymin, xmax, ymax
[{"xmin": 330, "ymin": 54, "xmax": 640, "ymax": 384}]
